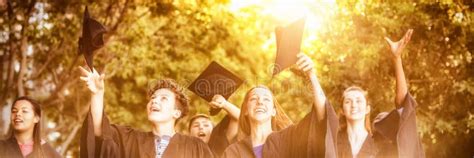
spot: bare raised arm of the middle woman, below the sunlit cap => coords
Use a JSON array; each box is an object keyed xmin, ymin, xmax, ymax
[{"xmin": 296, "ymin": 53, "xmax": 326, "ymax": 121}]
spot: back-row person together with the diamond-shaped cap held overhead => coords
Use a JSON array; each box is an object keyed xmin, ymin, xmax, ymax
[{"xmin": 188, "ymin": 61, "xmax": 243, "ymax": 156}]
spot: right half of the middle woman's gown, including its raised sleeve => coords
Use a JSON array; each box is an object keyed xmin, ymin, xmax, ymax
[{"xmin": 263, "ymin": 102, "xmax": 339, "ymax": 157}]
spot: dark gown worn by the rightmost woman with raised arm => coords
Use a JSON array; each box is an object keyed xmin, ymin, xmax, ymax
[{"xmin": 337, "ymin": 94, "xmax": 425, "ymax": 158}]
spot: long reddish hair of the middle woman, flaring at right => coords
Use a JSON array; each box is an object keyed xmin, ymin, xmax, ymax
[{"xmin": 239, "ymin": 85, "xmax": 293, "ymax": 136}]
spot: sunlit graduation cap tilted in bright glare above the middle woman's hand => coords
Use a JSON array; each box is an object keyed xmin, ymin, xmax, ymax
[{"xmin": 273, "ymin": 18, "xmax": 305, "ymax": 76}]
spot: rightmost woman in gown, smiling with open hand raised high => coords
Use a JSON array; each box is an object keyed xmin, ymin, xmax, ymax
[{"xmin": 312, "ymin": 29, "xmax": 425, "ymax": 158}]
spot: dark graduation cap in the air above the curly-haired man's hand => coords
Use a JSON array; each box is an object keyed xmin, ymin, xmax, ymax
[{"xmin": 79, "ymin": 6, "xmax": 107, "ymax": 70}]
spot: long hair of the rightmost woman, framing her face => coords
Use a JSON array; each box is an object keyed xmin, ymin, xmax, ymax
[{"xmin": 339, "ymin": 86, "xmax": 372, "ymax": 135}]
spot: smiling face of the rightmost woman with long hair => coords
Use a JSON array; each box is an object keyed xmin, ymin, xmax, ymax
[{"xmin": 343, "ymin": 90, "xmax": 370, "ymax": 121}]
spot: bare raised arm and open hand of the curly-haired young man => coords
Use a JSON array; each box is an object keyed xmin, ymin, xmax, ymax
[{"xmin": 79, "ymin": 67, "xmax": 105, "ymax": 136}]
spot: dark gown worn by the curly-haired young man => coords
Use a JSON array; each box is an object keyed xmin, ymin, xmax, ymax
[{"xmin": 80, "ymin": 113, "xmax": 214, "ymax": 158}]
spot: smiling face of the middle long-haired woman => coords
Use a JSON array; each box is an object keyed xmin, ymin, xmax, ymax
[{"xmin": 246, "ymin": 88, "xmax": 276, "ymax": 123}]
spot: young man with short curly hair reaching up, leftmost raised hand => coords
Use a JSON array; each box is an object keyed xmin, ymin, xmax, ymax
[{"xmin": 80, "ymin": 67, "xmax": 213, "ymax": 158}]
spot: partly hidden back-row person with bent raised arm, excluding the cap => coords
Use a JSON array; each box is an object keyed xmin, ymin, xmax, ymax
[{"xmin": 188, "ymin": 94, "xmax": 240, "ymax": 155}]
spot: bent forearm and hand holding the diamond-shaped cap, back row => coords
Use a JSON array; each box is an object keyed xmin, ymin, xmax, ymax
[{"xmin": 209, "ymin": 95, "xmax": 240, "ymax": 141}]
